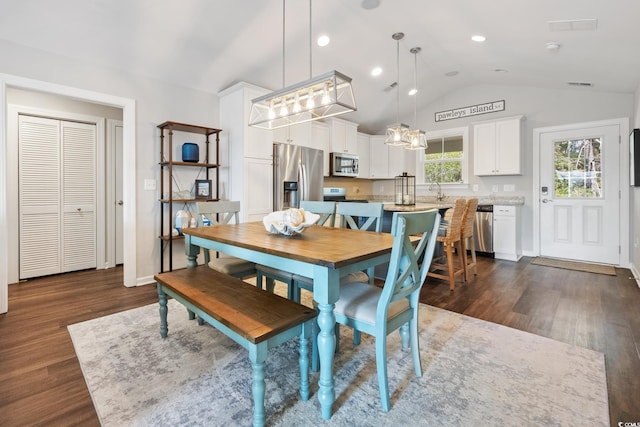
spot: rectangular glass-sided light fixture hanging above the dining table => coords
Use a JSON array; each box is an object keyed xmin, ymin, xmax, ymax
[{"xmin": 249, "ymin": 70, "xmax": 356, "ymax": 129}]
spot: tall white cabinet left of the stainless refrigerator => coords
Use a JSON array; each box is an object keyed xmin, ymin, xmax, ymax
[{"xmin": 218, "ymin": 82, "xmax": 273, "ymax": 222}]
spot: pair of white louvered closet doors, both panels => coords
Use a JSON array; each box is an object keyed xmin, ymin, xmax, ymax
[{"xmin": 18, "ymin": 115, "xmax": 96, "ymax": 279}]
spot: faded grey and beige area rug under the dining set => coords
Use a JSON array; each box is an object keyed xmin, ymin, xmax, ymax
[{"xmin": 68, "ymin": 300, "xmax": 609, "ymax": 427}]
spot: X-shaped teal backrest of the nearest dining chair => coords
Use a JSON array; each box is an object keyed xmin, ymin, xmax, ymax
[{"xmin": 376, "ymin": 209, "xmax": 440, "ymax": 322}]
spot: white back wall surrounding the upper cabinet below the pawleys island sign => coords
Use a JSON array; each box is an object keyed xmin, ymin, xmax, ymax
[{"xmin": 392, "ymin": 85, "xmax": 640, "ymax": 254}]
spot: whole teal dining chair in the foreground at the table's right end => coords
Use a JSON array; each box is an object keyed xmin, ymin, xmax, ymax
[{"xmin": 314, "ymin": 209, "xmax": 440, "ymax": 412}]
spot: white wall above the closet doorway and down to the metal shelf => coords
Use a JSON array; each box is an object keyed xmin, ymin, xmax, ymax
[{"xmin": 0, "ymin": 40, "xmax": 219, "ymax": 283}]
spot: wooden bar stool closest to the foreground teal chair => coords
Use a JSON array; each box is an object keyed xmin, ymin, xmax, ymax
[{"xmin": 428, "ymin": 199, "xmax": 467, "ymax": 290}]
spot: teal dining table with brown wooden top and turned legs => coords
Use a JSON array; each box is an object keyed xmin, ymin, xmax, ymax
[{"xmin": 183, "ymin": 222, "xmax": 393, "ymax": 420}]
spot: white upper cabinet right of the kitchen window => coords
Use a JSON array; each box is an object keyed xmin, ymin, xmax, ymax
[{"xmin": 473, "ymin": 116, "xmax": 523, "ymax": 176}]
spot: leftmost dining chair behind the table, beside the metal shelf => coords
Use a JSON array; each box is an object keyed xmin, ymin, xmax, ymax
[{"xmin": 196, "ymin": 200, "xmax": 256, "ymax": 279}]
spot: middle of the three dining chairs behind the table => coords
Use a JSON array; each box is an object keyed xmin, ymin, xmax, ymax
[{"xmin": 256, "ymin": 200, "xmax": 336, "ymax": 303}]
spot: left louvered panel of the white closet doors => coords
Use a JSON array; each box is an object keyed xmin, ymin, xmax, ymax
[{"xmin": 18, "ymin": 116, "xmax": 62, "ymax": 279}]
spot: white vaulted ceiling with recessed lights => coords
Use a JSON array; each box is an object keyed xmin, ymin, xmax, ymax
[{"xmin": 0, "ymin": 0, "xmax": 640, "ymax": 133}]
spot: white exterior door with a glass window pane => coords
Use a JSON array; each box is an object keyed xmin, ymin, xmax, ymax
[{"xmin": 538, "ymin": 125, "xmax": 620, "ymax": 265}]
